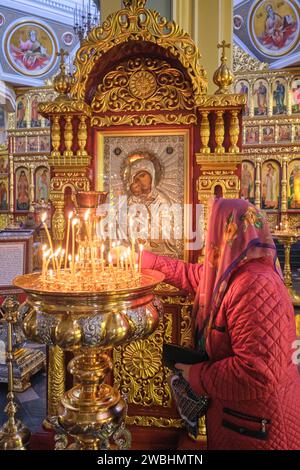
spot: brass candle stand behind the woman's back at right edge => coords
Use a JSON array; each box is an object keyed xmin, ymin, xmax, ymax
[{"xmin": 272, "ymin": 227, "xmax": 300, "ymax": 305}]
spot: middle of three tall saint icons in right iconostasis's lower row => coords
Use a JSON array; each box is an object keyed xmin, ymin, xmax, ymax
[{"xmin": 262, "ymin": 161, "xmax": 280, "ymax": 209}]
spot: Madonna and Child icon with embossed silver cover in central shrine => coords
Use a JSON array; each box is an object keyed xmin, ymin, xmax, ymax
[{"xmin": 96, "ymin": 130, "xmax": 188, "ymax": 257}]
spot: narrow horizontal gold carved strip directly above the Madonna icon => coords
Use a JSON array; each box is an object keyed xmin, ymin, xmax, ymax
[{"xmin": 91, "ymin": 113, "xmax": 197, "ymax": 127}]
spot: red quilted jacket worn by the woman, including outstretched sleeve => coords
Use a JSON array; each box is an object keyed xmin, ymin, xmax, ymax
[{"xmin": 143, "ymin": 253, "xmax": 300, "ymax": 450}]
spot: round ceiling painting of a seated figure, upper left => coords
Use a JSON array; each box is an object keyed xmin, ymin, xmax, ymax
[{"xmin": 4, "ymin": 20, "xmax": 57, "ymax": 77}]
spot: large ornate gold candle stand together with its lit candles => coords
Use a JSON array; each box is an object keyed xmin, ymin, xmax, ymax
[{"xmin": 14, "ymin": 193, "xmax": 164, "ymax": 450}]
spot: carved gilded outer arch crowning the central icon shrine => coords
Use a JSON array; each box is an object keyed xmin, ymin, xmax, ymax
[{"xmin": 70, "ymin": 0, "xmax": 207, "ymax": 103}]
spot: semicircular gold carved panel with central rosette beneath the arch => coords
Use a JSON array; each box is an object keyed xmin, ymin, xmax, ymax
[{"xmin": 91, "ymin": 57, "xmax": 194, "ymax": 113}]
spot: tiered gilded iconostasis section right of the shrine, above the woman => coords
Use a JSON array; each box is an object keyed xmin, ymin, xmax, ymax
[{"xmin": 235, "ymin": 70, "xmax": 300, "ymax": 231}]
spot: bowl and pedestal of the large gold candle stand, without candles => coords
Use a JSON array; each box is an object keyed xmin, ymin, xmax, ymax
[{"xmin": 14, "ymin": 270, "xmax": 164, "ymax": 450}]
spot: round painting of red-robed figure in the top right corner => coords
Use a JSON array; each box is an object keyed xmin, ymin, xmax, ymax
[{"xmin": 249, "ymin": 0, "xmax": 300, "ymax": 57}]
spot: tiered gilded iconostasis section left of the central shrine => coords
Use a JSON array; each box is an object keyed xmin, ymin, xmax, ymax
[{"xmin": 0, "ymin": 87, "xmax": 55, "ymax": 227}]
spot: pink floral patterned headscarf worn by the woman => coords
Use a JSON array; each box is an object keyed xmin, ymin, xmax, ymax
[{"xmin": 195, "ymin": 198, "xmax": 282, "ymax": 339}]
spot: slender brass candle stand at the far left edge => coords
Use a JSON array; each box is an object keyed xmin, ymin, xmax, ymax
[{"xmin": 0, "ymin": 297, "xmax": 30, "ymax": 450}]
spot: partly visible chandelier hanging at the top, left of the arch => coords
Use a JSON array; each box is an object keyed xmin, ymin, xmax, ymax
[{"xmin": 73, "ymin": 0, "xmax": 101, "ymax": 43}]
